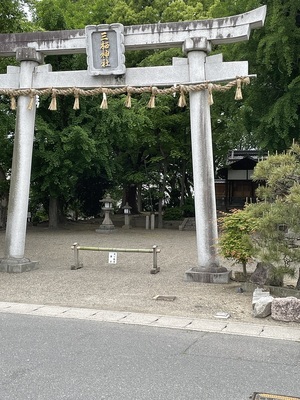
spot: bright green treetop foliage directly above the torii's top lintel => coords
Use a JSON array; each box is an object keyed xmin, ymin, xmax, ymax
[{"xmin": 32, "ymin": 0, "xmax": 211, "ymax": 30}]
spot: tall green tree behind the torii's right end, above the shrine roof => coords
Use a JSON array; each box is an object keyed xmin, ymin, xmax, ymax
[{"xmin": 210, "ymin": 0, "xmax": 300, "ymax": 157}]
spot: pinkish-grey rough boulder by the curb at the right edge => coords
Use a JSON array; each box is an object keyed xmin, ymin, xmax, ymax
[{"xmin": 271, "ymin": 297, "xmax": 300, "ymax": 322}]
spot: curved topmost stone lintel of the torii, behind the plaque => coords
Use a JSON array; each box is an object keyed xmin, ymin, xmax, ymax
[{"xmin": 0, "ymin": 6, "xmax": 266, "ymax": 57}]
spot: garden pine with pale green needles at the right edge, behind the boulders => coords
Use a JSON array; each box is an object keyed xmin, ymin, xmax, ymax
[{"xmin": 251, "ymin": 144, "xmax": 300, "ymax": 268}]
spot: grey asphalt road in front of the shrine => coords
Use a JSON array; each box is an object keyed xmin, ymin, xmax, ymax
[{"xmin": 0, "ymin": 313, "xmax": 300, "ymax": 400}]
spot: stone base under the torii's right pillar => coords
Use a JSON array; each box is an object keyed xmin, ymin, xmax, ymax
[{"xmin": 184, "ymin": 267, "xmax": 232, "ymax": 283}]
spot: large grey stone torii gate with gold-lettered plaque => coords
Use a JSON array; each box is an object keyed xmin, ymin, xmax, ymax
[{"xmin": 0, "ymin": 6, "xmax": 266, "ymax": 276}]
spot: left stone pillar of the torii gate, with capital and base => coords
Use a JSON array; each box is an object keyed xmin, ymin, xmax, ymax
[{"xmin": 1, "ymin": 47, "xmax": 43, "ymax": 272}]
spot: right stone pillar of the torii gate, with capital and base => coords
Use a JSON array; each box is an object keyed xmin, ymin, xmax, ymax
[{"xmin": 183, "ymin": 37, "xmax": 221, "ymax": 282}]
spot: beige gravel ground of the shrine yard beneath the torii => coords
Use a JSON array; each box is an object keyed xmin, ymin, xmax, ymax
[{"xmin": 0, "ymin": 223, "xmax": 299, "ymax": 326}]
